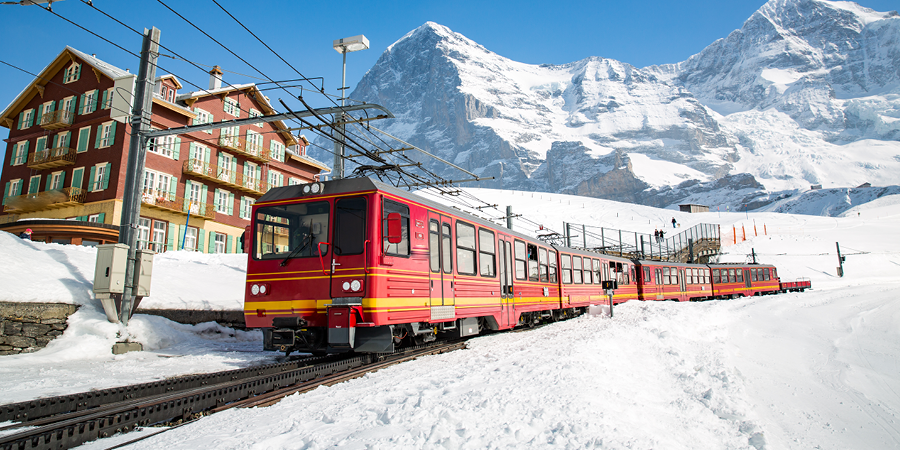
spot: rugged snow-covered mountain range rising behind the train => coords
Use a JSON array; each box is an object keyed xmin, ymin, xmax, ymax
[{"xmin": 318, "ymin": 0, "xmax": 900, "ymax": 211}]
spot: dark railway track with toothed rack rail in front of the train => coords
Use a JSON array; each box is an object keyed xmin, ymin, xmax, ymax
[{"xmin": 0, "ymin": 342, "xmax": 465, "ymax": 450}]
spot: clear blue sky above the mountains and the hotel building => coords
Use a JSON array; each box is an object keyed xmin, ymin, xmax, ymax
[{"xmin": 0, "ymin": 0, "xmax": 898, "ymax": 149}]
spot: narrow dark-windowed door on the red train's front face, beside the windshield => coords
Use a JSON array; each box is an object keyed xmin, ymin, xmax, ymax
[{"xmin": 328, "ymin": 196, "xmax": 372, "ymax": 298}]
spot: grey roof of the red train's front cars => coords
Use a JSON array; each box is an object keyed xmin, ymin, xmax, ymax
[{"xmin": 256, "ymin": 178, "xmax": 631, "ymax": 262}]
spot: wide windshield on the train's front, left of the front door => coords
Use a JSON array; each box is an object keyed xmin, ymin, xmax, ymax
[{"xmin": 254, "ymin": 202, "xmax": 331, "ymax": 259}]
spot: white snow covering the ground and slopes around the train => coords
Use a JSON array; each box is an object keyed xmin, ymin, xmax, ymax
[{"xmin": 0, "ymin": 185, "xmax": 900, "ymax": 449}]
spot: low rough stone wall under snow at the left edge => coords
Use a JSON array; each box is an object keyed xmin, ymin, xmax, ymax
[{"xmin": 0, "ymin": 302, "xmax": 78, "ymax": 355}]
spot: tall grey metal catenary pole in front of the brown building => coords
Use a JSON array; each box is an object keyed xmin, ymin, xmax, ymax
[{"xmin": 119, "ymin": 27, "xmax": 160, "ymax": 326}]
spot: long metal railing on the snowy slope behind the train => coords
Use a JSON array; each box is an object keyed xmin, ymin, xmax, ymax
[{"xmin": 543, "ymin": 223, "xmax": 722, "ymax": 262}]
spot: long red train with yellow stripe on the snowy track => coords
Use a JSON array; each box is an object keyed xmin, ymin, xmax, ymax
[{"xmin": 244, "ymin": 178, "xmax": 810, "ymax": 354}]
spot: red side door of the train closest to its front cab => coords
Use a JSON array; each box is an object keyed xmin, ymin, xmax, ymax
[{"xmin": 428, "ymin": 211, "xmax": 454, "ymax": 307}]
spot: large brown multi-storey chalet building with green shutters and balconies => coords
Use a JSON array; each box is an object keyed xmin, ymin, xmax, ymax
[{"xmin": 0, "ymin": 47, "xmax": 330, "ymax": 253}]
